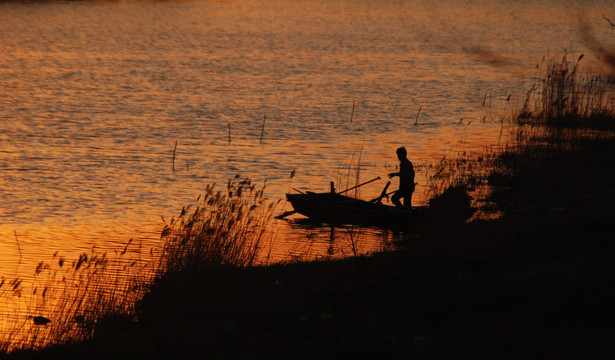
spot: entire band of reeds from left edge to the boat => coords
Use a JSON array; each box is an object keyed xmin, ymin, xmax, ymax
[{"xmin": 0, "ymin": 176, "xmax": 277, "ymax": 355}]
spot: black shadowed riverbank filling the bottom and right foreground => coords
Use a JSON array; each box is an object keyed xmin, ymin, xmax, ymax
[{"xmin": 10, "ymin": 133, "xmax": 615, "ymax": 359}]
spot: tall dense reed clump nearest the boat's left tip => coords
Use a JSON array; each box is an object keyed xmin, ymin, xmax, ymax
[{"xmin": 156, "ymin": 176, "xmax": 277, "ymax": 276}]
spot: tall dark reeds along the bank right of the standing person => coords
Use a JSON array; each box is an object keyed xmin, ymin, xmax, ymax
[{"xmin": 424, "ymin": 54, "xmax": 615, "ymax": 218}]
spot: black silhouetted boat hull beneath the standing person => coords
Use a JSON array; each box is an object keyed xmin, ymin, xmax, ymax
[{"xmin": 286, "ymin": 192, "xmax": 429, "ymax": 227}]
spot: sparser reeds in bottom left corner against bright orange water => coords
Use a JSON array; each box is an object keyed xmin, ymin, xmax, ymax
[{"xmin": 0, "ymin": 240, "xmax": 151, "ymax": 353}]
